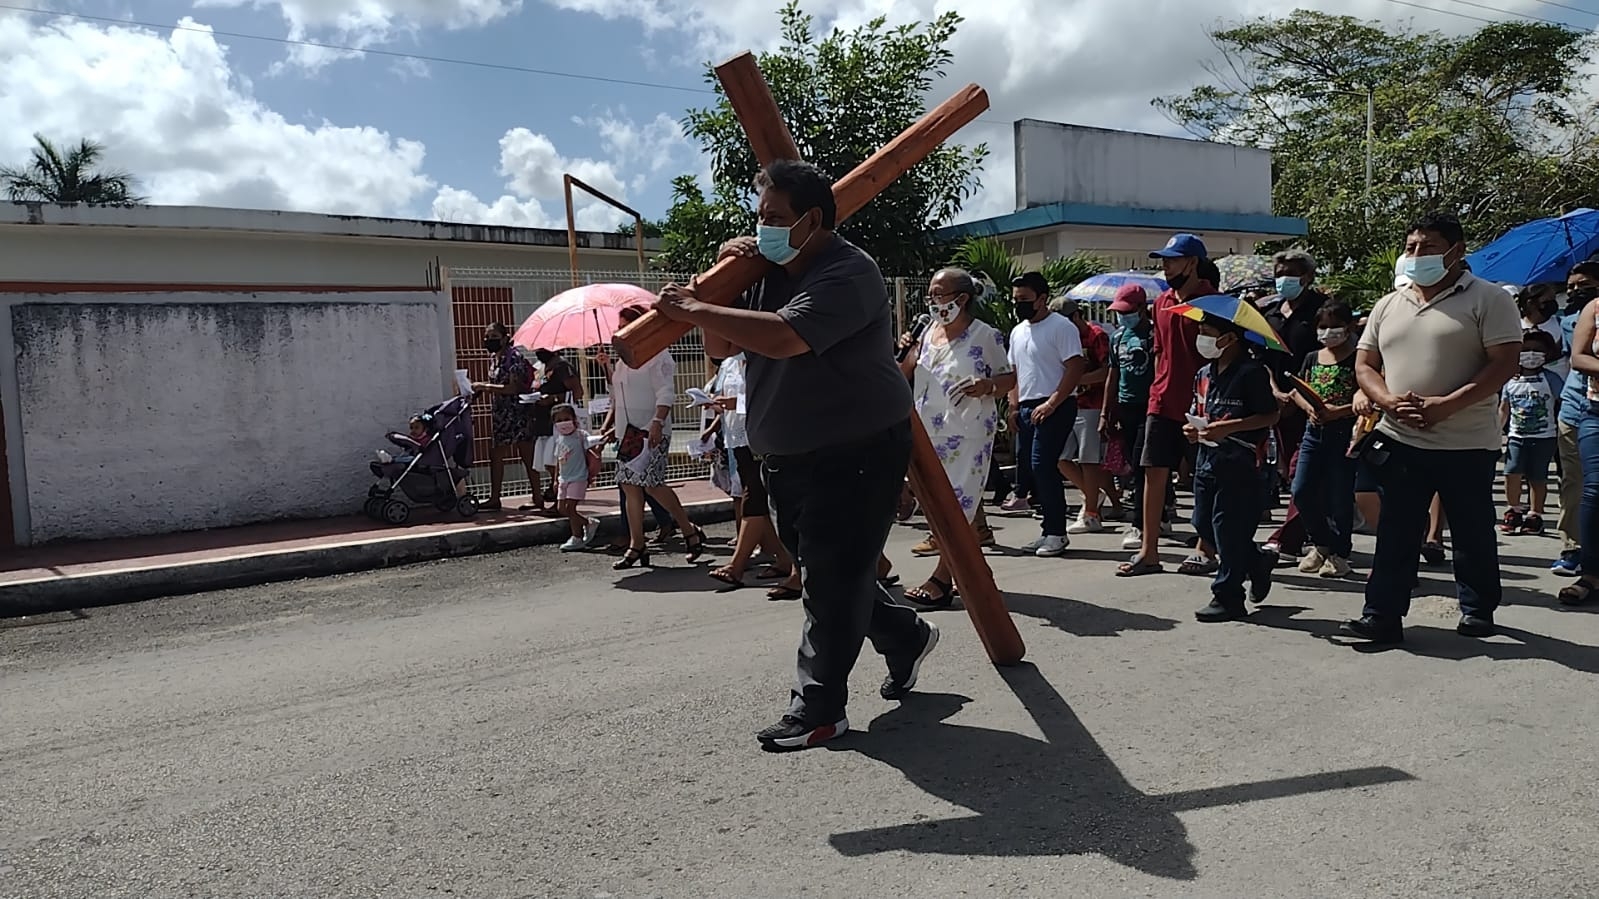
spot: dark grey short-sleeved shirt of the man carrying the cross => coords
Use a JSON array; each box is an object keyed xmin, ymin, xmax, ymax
[{"xmin": 739, "ymin": 235, "xmax": 911, "ymax": 456}]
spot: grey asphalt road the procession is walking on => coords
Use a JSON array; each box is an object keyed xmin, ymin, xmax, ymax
[{"xmin": 0, "ymin": 508, "xmax": 1599, "ymax": 899}]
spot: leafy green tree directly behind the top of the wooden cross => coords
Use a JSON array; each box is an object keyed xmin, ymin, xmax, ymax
[{"xmin": 657, "ymin": 0, "xmax": 988, "ymax": 274}]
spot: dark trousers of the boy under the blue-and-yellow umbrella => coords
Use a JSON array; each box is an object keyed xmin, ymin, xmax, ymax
[{"xmin": 1193, "ymin": 462, "xmax": 1263, "ymax": 605}]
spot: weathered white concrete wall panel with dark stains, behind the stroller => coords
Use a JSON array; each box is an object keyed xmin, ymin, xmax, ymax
[{"xmin": 5, "ymin": 294, "xmax": 453, "ymax": 544}]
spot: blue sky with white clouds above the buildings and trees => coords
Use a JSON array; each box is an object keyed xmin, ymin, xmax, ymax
[{"xmin": 0, "ymin": 0, "xmax": 1599, "ymax": 229}]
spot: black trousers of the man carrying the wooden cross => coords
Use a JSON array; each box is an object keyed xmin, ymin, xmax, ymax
[{"xmin": 763, "ymin": 419, "xmax": 923, "ymax": 725}]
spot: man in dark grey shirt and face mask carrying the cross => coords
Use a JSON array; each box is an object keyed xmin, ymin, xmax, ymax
[{"xmin": 656, "ymin": 160, "xmax": 939, "ymax": 750}]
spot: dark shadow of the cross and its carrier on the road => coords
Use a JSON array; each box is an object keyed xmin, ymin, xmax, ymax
[{"xmin": 830, "ymin": 664, "xmax": 1414, "ymax": 880}]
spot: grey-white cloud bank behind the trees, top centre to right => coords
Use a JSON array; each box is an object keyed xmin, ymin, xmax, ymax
[{"xmin": 534, "ymin": 0, "xmax": 1573, "ymax": 219}]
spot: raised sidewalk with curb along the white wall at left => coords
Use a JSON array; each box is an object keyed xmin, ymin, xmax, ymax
[{"xmin": 0, "ymin": 480, "xmax": 732, "ymax": 617}]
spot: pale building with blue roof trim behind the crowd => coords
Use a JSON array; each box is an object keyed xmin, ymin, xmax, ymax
[{"xmin": 937, "ymin": 118, "xmax": 1306, "ymax": 269}]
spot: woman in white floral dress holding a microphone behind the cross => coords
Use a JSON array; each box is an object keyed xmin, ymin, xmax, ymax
[{"xmin": 900, "ymin": 269, "xmax": 1015, "ymax": 608}]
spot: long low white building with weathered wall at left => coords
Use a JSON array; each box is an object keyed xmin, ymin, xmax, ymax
[{"xmin": 0, "ymin": 203, "xmax": 652, "ymax": 547}]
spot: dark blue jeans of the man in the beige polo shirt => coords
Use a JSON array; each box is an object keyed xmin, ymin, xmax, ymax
[{"xmin": 1364, "ymin": 438, "xmax": 1496, "ymax": 621}]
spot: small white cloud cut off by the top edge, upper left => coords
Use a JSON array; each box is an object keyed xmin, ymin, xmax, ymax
[{"xmin": 195, "ymin": 0, "xmax": 521, "ymax": 70}]
